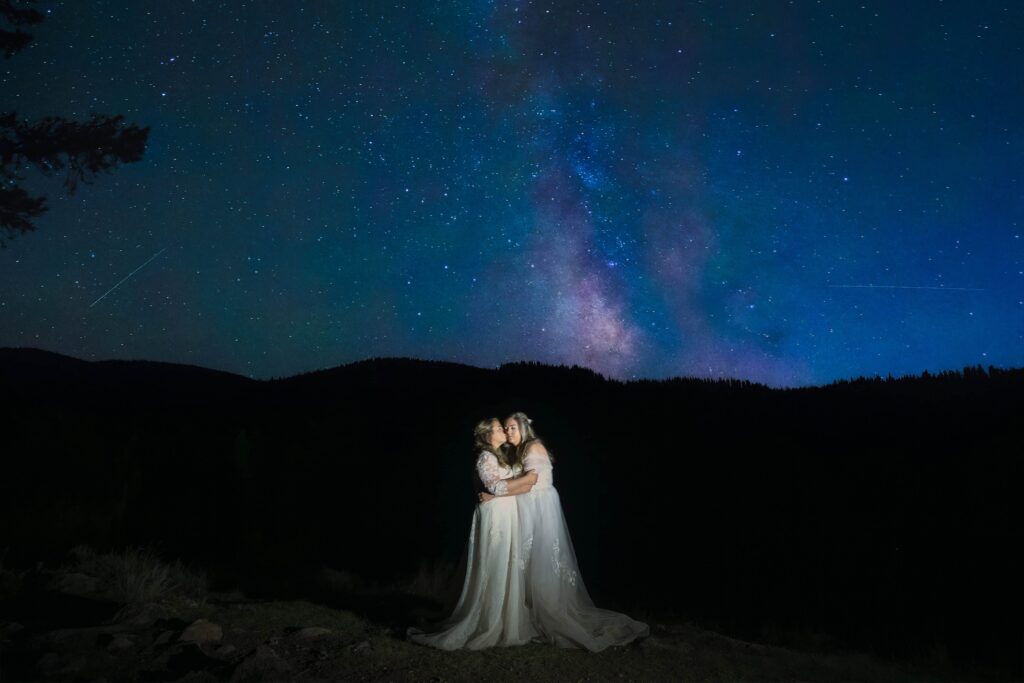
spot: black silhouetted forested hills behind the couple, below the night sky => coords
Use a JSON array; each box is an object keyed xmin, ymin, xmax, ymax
[{"xmin": 0, "ymin": 349, "xmax": 1024, "ymax": 677}]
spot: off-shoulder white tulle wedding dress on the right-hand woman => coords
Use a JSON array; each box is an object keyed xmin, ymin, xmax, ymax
[{"xmin": 516, "ymin": 451, "xmax": 649, "ymax": 652}]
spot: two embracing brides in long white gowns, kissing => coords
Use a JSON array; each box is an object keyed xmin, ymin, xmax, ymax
[{"xmin": 409, "ymin": 413, "xmax": 649, "ymax": 652}]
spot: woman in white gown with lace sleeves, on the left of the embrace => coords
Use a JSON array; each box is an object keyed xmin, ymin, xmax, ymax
[{"xmin": 409, "ymin": 418, "xmax": 538, "ymax": 650}]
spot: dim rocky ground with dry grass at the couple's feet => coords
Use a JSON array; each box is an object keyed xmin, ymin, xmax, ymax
[{"xmin": 0, "ymin": 557, "xmax": 958, "ymax": 681}]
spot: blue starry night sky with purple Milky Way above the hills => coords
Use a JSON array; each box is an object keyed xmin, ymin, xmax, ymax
[{"xmin": 0, "ymin": 0, "xmax": 1024, "ymax": 386}]
